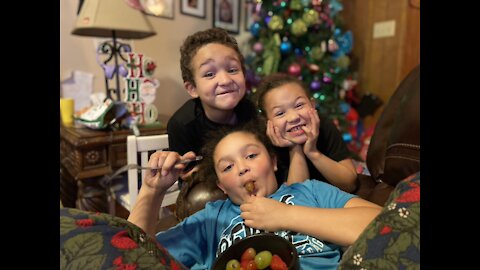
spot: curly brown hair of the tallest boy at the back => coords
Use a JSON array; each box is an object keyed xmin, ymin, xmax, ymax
[{"xmin": 180, "ymin": 28, "xmax": 245, "ymax": 86}]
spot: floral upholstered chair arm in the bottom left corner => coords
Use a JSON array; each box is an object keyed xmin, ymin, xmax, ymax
[{"xmin": 60, "ymin": 208, "xmax": 187, "ymax": 270}]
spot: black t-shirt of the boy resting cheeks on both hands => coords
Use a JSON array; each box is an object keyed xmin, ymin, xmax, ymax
[{"xmin": 275, "ymin": 115, "xmax": 352, "ymax": 183}]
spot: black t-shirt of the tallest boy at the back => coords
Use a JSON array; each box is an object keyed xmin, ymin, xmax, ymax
[{"xmin": 167, "ymin": 98, "xmax": 256, "ymax": 155}]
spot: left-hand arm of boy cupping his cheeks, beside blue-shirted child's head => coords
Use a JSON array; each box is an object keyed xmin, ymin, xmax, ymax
[{"xmin": 267, "ymin": 120, "xmax": 310, "ymax": 185}]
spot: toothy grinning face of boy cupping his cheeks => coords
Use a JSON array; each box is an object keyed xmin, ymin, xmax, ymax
[{"xmin": 263, "ymin": 82, "xmax": 313, "ymax": 144}]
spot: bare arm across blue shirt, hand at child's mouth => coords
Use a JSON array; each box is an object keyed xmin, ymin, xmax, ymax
[{"xmin": 240, "ymin": 196, "xmax": 381, "ymax": 246}]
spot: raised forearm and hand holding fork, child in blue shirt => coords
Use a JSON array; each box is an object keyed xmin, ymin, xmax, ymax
[{"xmin": 128, "ymin": 151, "xmax": 195, "ymax": 236}]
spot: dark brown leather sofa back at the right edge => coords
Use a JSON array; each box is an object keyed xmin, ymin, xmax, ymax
[{"xmin": 354, "ymin": 66, "xmax": 420, "ymax": 206}]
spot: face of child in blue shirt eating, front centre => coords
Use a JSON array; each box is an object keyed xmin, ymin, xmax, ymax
[{"xmin": 213, "ymin": 131, "xmax": 278, "ymax": 205}]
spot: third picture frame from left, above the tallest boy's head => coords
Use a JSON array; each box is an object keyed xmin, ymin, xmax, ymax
[{"xmin": 213, "ymin": 0, "xmax": 241, "ymax": 34}]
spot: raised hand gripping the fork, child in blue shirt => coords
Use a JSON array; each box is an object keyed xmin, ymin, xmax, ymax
[{"xmin": 143, "ymin": 151, "xmax": 195, "ymax": 192}]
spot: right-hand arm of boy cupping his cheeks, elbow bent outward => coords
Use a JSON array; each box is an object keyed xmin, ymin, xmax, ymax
[{"xmin": 303, "ymin": 109, "xmax": 357, "ymax": 192}]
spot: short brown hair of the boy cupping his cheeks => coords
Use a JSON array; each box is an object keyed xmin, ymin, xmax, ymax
[{"xmin": 254, "ymin": 73, "xmax": 311, "ymax": 117}]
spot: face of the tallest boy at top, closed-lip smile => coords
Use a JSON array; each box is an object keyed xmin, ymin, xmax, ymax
[{"xmin": 185, "ymin": 43, "xmax": 246, "ymax": 120}]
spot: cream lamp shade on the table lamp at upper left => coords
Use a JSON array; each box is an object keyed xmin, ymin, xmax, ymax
[{"xmin": 72, "ymin": 0, "xmax": 156, "ymax": 39}]
